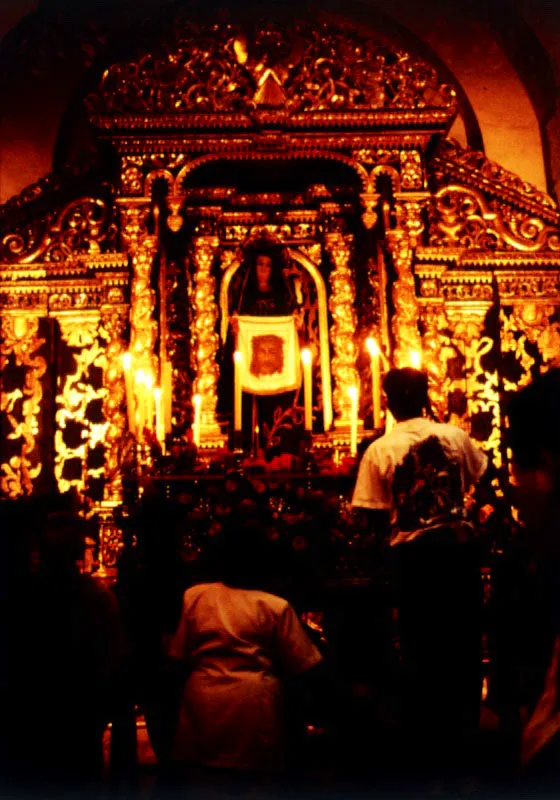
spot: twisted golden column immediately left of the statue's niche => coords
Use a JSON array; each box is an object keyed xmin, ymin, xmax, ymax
[{"xmin": 192, "ymin": 235, "xmax": 226, "ymax": 447}]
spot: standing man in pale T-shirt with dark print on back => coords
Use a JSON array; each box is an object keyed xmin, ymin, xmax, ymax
[{"xmin": 352, "ymin": 368, "xmax": 487, "ymax": 770}]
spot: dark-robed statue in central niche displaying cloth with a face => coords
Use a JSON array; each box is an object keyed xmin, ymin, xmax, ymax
[{"xmin": 221, "ymin": 237, "xmax": 320, "ymax": 459}]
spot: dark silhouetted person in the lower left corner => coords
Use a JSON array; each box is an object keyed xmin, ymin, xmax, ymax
[{"xmin": 3, "ymin": 512, "xmax": 123, "ymax": 791}]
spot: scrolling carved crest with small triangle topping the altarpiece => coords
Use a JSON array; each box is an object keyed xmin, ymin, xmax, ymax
[{"xmin": 87, "ymin": 22, "xmax": 456, "ymax": 115}]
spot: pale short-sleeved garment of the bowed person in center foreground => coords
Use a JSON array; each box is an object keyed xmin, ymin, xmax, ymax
[{"xmin": 170, "ymin": 583, "xmax": 321, "ymax": 770}]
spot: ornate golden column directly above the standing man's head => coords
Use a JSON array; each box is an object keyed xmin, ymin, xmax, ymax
[{"xmin": 385, "ymin": 192, "xmax": 429, "ymax": 367}]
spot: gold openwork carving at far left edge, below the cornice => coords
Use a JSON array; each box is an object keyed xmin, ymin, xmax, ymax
[{"xmin": 0, "ymin": 314, "xmax": 47, "ymax": 499}]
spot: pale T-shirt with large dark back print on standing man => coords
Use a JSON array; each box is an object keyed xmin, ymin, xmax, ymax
[{"xmin": 352, "ymin": 417, "xmax": 488, "ymax": 545}]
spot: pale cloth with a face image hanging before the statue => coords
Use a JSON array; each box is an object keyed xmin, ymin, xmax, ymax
[{"xmin": 237, "ymin": 316, "xmax": 301, "ymax": 394}]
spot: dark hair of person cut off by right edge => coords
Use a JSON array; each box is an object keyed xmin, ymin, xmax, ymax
[{"xmin": 507, "ymin": 368, "xmax": 560, "ymax": 470}]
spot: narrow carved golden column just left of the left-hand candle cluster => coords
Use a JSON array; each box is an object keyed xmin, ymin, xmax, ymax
[{"xmin": 101, "ymin": 305, "xmax": 128, "ymax": 502}]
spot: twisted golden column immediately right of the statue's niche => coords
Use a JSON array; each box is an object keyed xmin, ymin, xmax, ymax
[{"xmin": 325, "ymin": 233, "xmax": 360, "ymax": 429}]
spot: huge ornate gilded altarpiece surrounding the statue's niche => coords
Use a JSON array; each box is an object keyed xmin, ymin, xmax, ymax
[{"xmin": 0, "ymin": 19, "xmax": 560, "ymax": 566}]
